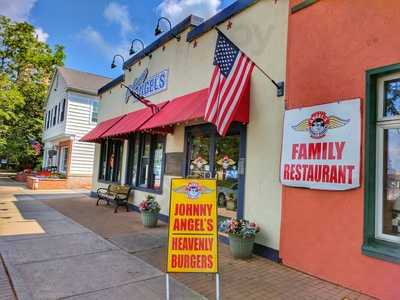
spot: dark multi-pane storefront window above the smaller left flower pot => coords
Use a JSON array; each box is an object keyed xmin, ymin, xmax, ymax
[{"xmin": 127, "ymin": 134, "xmax": 165, "ymax": 191}]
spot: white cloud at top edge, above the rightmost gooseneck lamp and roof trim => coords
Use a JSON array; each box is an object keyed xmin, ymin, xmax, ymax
[{"xmin": 157, "ymin": 0, "xmax": 221, "ymax": 26}]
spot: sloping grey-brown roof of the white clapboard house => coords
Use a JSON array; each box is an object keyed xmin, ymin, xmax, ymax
[{"xmin": 57, "ymin": 67, "xmax": 111, "ymax": 95}]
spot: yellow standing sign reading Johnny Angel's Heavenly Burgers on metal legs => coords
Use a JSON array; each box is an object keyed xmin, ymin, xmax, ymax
[{"xmin": 166, "ymin": 178, "xmax": 220, "ymax": 299}]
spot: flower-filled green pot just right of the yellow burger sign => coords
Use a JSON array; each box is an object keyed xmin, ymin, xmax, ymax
[{"xmin": 220, "ymin": 218, "xmax": 260, "ymax": 258}]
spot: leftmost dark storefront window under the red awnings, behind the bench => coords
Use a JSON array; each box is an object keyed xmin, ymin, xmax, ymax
[{"xmin": 99, "ymin": 140, "xmax": 123, "ymax": 182}]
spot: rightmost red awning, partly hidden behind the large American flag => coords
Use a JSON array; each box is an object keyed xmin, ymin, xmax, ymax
[{"xmin": 140, "ymin": 88, "xmax": 249, "ymax": 132}]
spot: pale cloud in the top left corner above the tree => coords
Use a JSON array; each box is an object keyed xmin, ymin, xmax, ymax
[{"xmin": 0, "ymin": 0, "xmax": 36, "ymax": 22}]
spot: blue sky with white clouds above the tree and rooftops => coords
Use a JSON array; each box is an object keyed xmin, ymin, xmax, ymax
[{"xmin": 0, "ymin": 0, "xmax": 234, "ymax": 77}]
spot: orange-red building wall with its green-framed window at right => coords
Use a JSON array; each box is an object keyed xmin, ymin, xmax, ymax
[{"xmin": 279, "ymin": 0, "xmax": 400, "ymax": 299}]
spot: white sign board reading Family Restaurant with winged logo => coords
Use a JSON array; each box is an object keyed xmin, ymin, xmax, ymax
[{"xmin": 280, "ymin": 99, "xmax": 361, "ymax": 190}]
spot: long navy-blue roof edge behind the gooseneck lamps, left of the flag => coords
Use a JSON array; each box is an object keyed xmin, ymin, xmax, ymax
[{"xmin": 123, "ymin": 15, "xmax": 204, "ymax": 70}]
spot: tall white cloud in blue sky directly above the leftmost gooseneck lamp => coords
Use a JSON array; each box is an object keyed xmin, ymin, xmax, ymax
[{"xmin": 104, "ymin": 2, "xmax": 134, "ymax": 37}]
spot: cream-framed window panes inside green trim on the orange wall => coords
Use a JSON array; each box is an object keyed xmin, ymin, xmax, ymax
[{"xmin": 376, "ymin": 78, "xmax": 400, "ymax": 242}]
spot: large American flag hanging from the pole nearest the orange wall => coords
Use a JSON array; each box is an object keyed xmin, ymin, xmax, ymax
[{"xmin": 204, "ymin": 32, "xmax": 254, "ymax": 136}]
